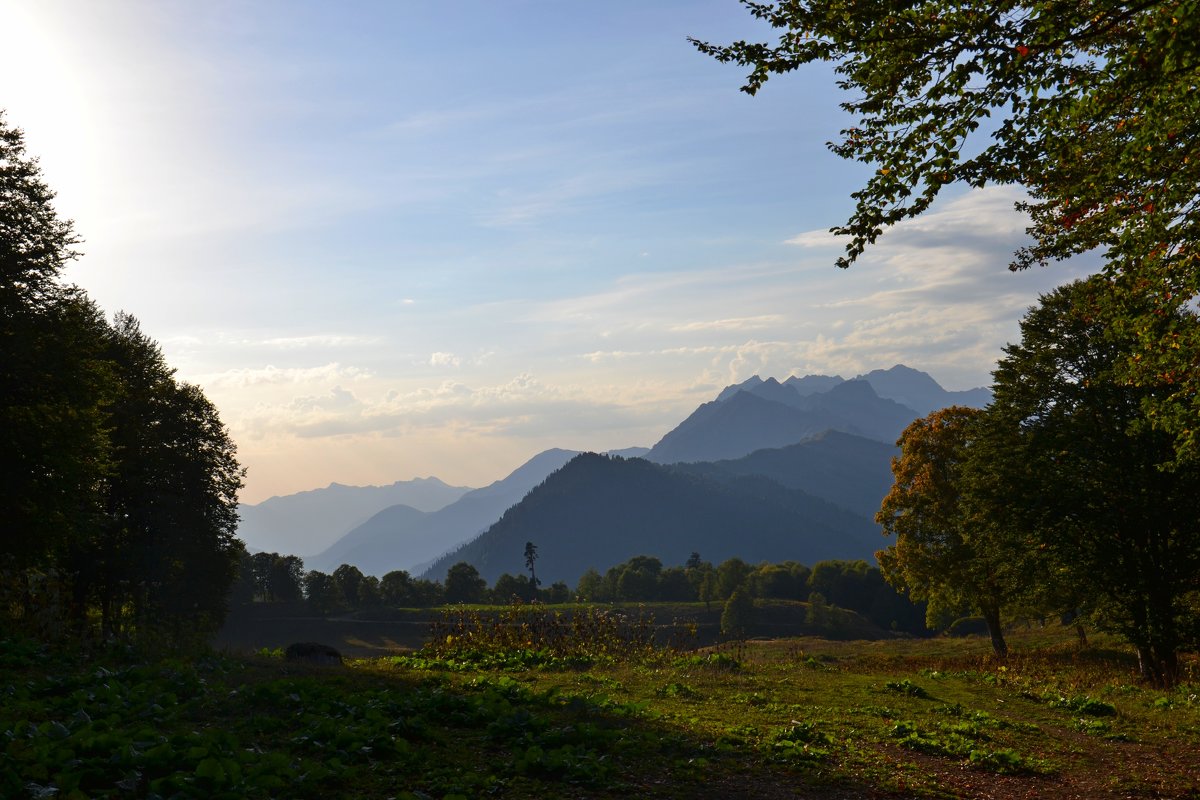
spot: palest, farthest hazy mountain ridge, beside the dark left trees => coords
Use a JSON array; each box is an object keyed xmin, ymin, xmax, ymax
[{"xmin": 238, "ymin": 477, "xmax": 472, "ymax": 555}]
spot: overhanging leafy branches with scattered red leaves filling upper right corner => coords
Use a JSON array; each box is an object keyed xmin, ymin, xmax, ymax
[{"xmin": 694, "ymin": 0, "xmax": 1200, "ymax": 470}]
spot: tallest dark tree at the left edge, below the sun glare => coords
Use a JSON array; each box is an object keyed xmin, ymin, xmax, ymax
[{"xmin": 0, "ymin": 112, "xmax": 111, "ymax": 582}]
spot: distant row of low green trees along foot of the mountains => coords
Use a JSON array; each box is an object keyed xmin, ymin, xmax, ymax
[{"xmin": 234, "ymin": 553, "xmax": 930, "ymax": 636}]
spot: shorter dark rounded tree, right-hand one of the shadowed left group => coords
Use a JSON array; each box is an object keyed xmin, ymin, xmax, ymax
[{"xmin": 82, "ymin": 313, "xmax": 245, "ymax": 642}]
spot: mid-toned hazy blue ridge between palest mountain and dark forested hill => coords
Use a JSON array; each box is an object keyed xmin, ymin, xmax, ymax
[{"xmin": 305, "ymin": 449, "xmax": 578, "ymax": 576}]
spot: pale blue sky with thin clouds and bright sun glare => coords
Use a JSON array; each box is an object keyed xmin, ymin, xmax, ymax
[{"xmin": 0, "ymin": 0, "xmax": 1090, "ymax": 503}]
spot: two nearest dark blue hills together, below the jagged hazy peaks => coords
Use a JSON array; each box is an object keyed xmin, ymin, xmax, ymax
[{"xmin": 417, "ymin": 433, "xmax": 895, "ymax": 585}]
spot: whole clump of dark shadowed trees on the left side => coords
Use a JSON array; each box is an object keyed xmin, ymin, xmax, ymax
[{"xmin": 0, "ymin": 112, "xmax": 242, "ymax": 646}]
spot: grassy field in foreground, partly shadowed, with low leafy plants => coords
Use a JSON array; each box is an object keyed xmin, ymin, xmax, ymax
[{"xmin": 0, "ymin": 606, "xmax": 1200, "ymax": 800}]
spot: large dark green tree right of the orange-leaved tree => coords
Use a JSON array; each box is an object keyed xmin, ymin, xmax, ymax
[{"xmin": 984, "ymin": 277, "xmax": 1200, "ymax": 686}]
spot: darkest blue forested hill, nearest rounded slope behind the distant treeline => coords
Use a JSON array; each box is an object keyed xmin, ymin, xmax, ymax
[{"xmin": 426, "ymin": 453, "xmax": 884, "ymax": 585}]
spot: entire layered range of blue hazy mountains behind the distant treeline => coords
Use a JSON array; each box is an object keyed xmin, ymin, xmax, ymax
[{"xmin": 229, "ymin": 365, "xmax": 991, "ymax": 583}]
